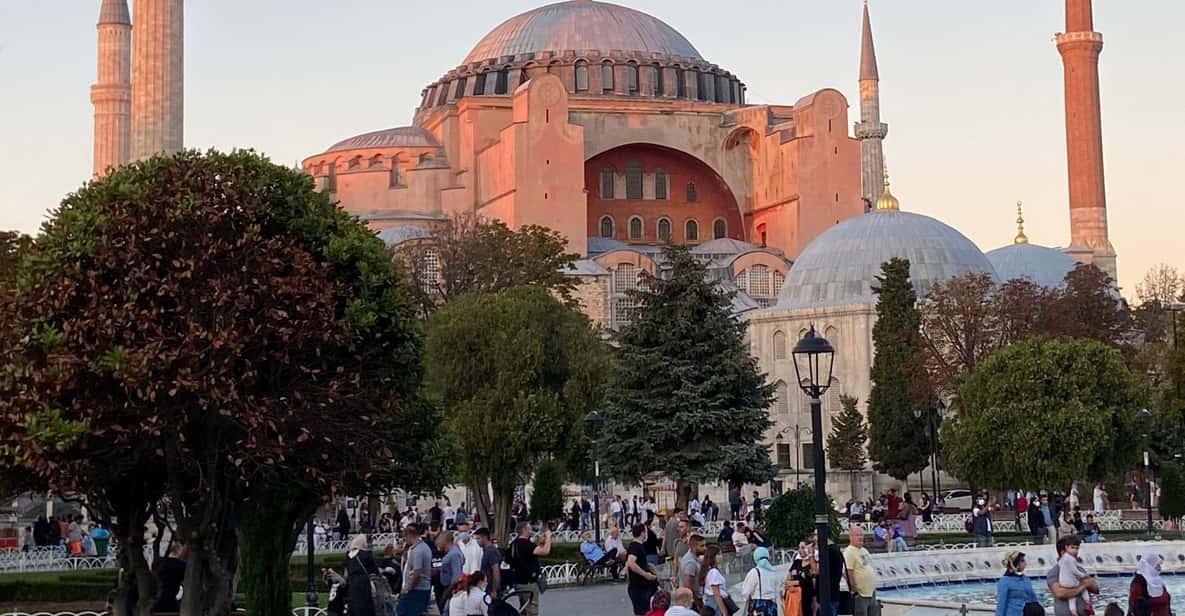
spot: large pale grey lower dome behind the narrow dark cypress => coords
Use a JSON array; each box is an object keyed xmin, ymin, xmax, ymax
[{"xmin": 777, "ymin": 210, "xmax": 995, "ymax": 308}]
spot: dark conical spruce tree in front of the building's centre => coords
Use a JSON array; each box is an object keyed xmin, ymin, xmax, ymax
[{"xmin": 602, "ymin": 246, "xmax": 774, "ymax": 503}]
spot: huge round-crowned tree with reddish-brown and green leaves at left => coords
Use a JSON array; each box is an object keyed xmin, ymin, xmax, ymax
[{"xmin": 0, "ymin": 152, "xmax": 430, "ymax": 615}]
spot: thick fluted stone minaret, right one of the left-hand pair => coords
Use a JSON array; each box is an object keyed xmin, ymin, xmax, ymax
[{"xmin": 132, "ymin": 0, "xmax": 185, "ymax": 160}]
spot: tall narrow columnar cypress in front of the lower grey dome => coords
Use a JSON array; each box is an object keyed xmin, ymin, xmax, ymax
[{"xmin": 869, "ymin": 258, "xmax": 930, "ymax": 480}]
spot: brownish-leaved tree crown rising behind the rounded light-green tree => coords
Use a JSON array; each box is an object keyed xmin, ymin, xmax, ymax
[{"xmin": 396, "ymin": 214, "xmax": 579, "ymax": 316}]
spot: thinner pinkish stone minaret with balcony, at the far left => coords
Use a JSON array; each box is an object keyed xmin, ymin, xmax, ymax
[{"xmin": 90, "ymin": 0, "xmax": 132, "ymax": 177}]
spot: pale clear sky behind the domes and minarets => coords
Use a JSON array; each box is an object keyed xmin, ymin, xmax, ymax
[{"xmin": 0, "ymin": 0, "xmax": 1185, "ymax": 295}]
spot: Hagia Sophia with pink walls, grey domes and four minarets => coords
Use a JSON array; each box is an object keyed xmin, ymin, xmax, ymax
[{"xmin": 91, "ymin": 0, "xmax": 1116, "ymax": 498}]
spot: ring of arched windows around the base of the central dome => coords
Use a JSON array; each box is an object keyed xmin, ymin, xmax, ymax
[{"xmin": 421, "ymin": 59, "xmax": 744, "ymax": 107}]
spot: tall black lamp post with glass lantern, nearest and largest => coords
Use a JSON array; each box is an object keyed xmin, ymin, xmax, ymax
[{"xmin": 793, "ymin": 325, "xmax": 838, "ymax": 616}]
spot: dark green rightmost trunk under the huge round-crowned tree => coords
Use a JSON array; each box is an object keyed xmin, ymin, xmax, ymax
[{"xmin": 238, "ymin": 489, "xmax": 308, "ymax": 616}]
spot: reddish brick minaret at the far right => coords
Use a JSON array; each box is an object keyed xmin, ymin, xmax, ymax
[{"xmin": 1057, "ymin": 0, "xmax": 1116, "ymax": 278}]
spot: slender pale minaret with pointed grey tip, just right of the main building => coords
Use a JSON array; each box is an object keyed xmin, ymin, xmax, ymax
[{"xmin": 856, "ymin": 1, "xmax": 889, "ymax": 208}]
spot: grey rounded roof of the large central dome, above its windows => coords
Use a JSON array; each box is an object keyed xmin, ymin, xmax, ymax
[{"xmin": 465, "ymin": 0, "xmax": 702, "ymax": 64}]
